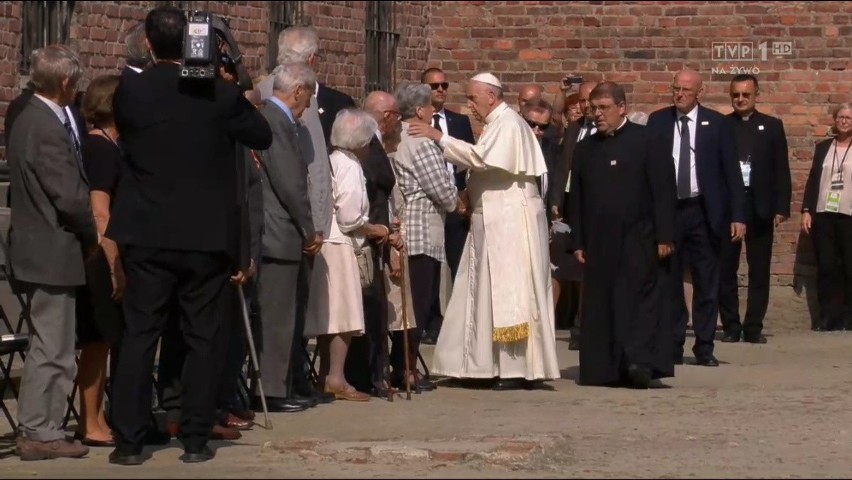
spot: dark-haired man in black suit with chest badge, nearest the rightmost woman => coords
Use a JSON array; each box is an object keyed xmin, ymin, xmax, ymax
[{"xmin": 719, "ymin": 74, "xmax": 792, "ymax": 343}]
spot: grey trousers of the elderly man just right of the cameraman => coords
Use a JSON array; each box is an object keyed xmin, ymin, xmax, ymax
[{"xmin": 255, "ymin": 257, "xmax": 306, "ymax": 398}]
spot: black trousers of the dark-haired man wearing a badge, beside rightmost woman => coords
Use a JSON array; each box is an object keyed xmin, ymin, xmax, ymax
[{"xmin": 719, "ymin": 193, "xmax": 775, "ymax": 336}]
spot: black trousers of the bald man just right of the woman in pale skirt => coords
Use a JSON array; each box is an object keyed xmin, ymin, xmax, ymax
[{"xmin": 344, "ymin": 246, "xmax": 388, "ymax": 393}]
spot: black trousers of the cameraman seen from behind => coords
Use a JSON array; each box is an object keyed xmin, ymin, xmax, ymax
[{"xmin": 112, "ymin": 246, "xmax": 232, "ymax": 454}]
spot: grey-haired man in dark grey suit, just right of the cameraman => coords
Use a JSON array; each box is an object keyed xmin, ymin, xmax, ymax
[{"xmin": 259, "ymin": 63, "xmax": 323, "ymax": 412}]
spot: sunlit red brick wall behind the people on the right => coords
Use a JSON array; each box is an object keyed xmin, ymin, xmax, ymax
[{"xmin": 429, "ymin": 1, "xmax": 852, "ymax": 285}]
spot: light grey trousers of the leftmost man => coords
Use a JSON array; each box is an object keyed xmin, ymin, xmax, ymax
[{"xmin": 18, "ymin": 284, "xmax": 77, "ymax": 442}]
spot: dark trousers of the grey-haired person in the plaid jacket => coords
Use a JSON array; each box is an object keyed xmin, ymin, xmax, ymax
[{"xmin": 390, "ymin": 255, "xmax": 441, "ymax": 378}]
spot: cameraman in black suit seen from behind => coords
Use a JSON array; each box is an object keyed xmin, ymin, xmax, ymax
[{"xmin": 106, "ymin": 7, "xmax": 272, "ymax": 465}]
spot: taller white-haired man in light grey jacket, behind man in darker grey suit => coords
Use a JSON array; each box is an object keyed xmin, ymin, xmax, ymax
[{"xmin": 257, "ymin": 27, "xmax": 334, "ymax": 403}]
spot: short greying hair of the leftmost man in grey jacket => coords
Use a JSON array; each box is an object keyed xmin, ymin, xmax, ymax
[{"xmin": 30, "ymin": 44, "xmax": 83, "ymax": 96}]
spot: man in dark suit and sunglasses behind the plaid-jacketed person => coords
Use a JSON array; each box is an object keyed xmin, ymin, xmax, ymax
[{"xmin": 420, "ymin": 67, "xmax": 476, "ymax": 345}]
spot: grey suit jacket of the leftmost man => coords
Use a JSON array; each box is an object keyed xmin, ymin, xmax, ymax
[{"xmin": 8, "ymin": 97, "xmax": 98, "ymax": 287}]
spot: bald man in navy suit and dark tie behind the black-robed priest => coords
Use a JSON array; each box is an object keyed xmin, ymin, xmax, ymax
[{"xmin": 648, "ymin": 70, "xmax": 746, "ymax": 367}]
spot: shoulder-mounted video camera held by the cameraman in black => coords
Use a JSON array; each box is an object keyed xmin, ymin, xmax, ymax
[{"xmin": 180, "ymin": 11, "xmax": 252, "ymax": 90}]
